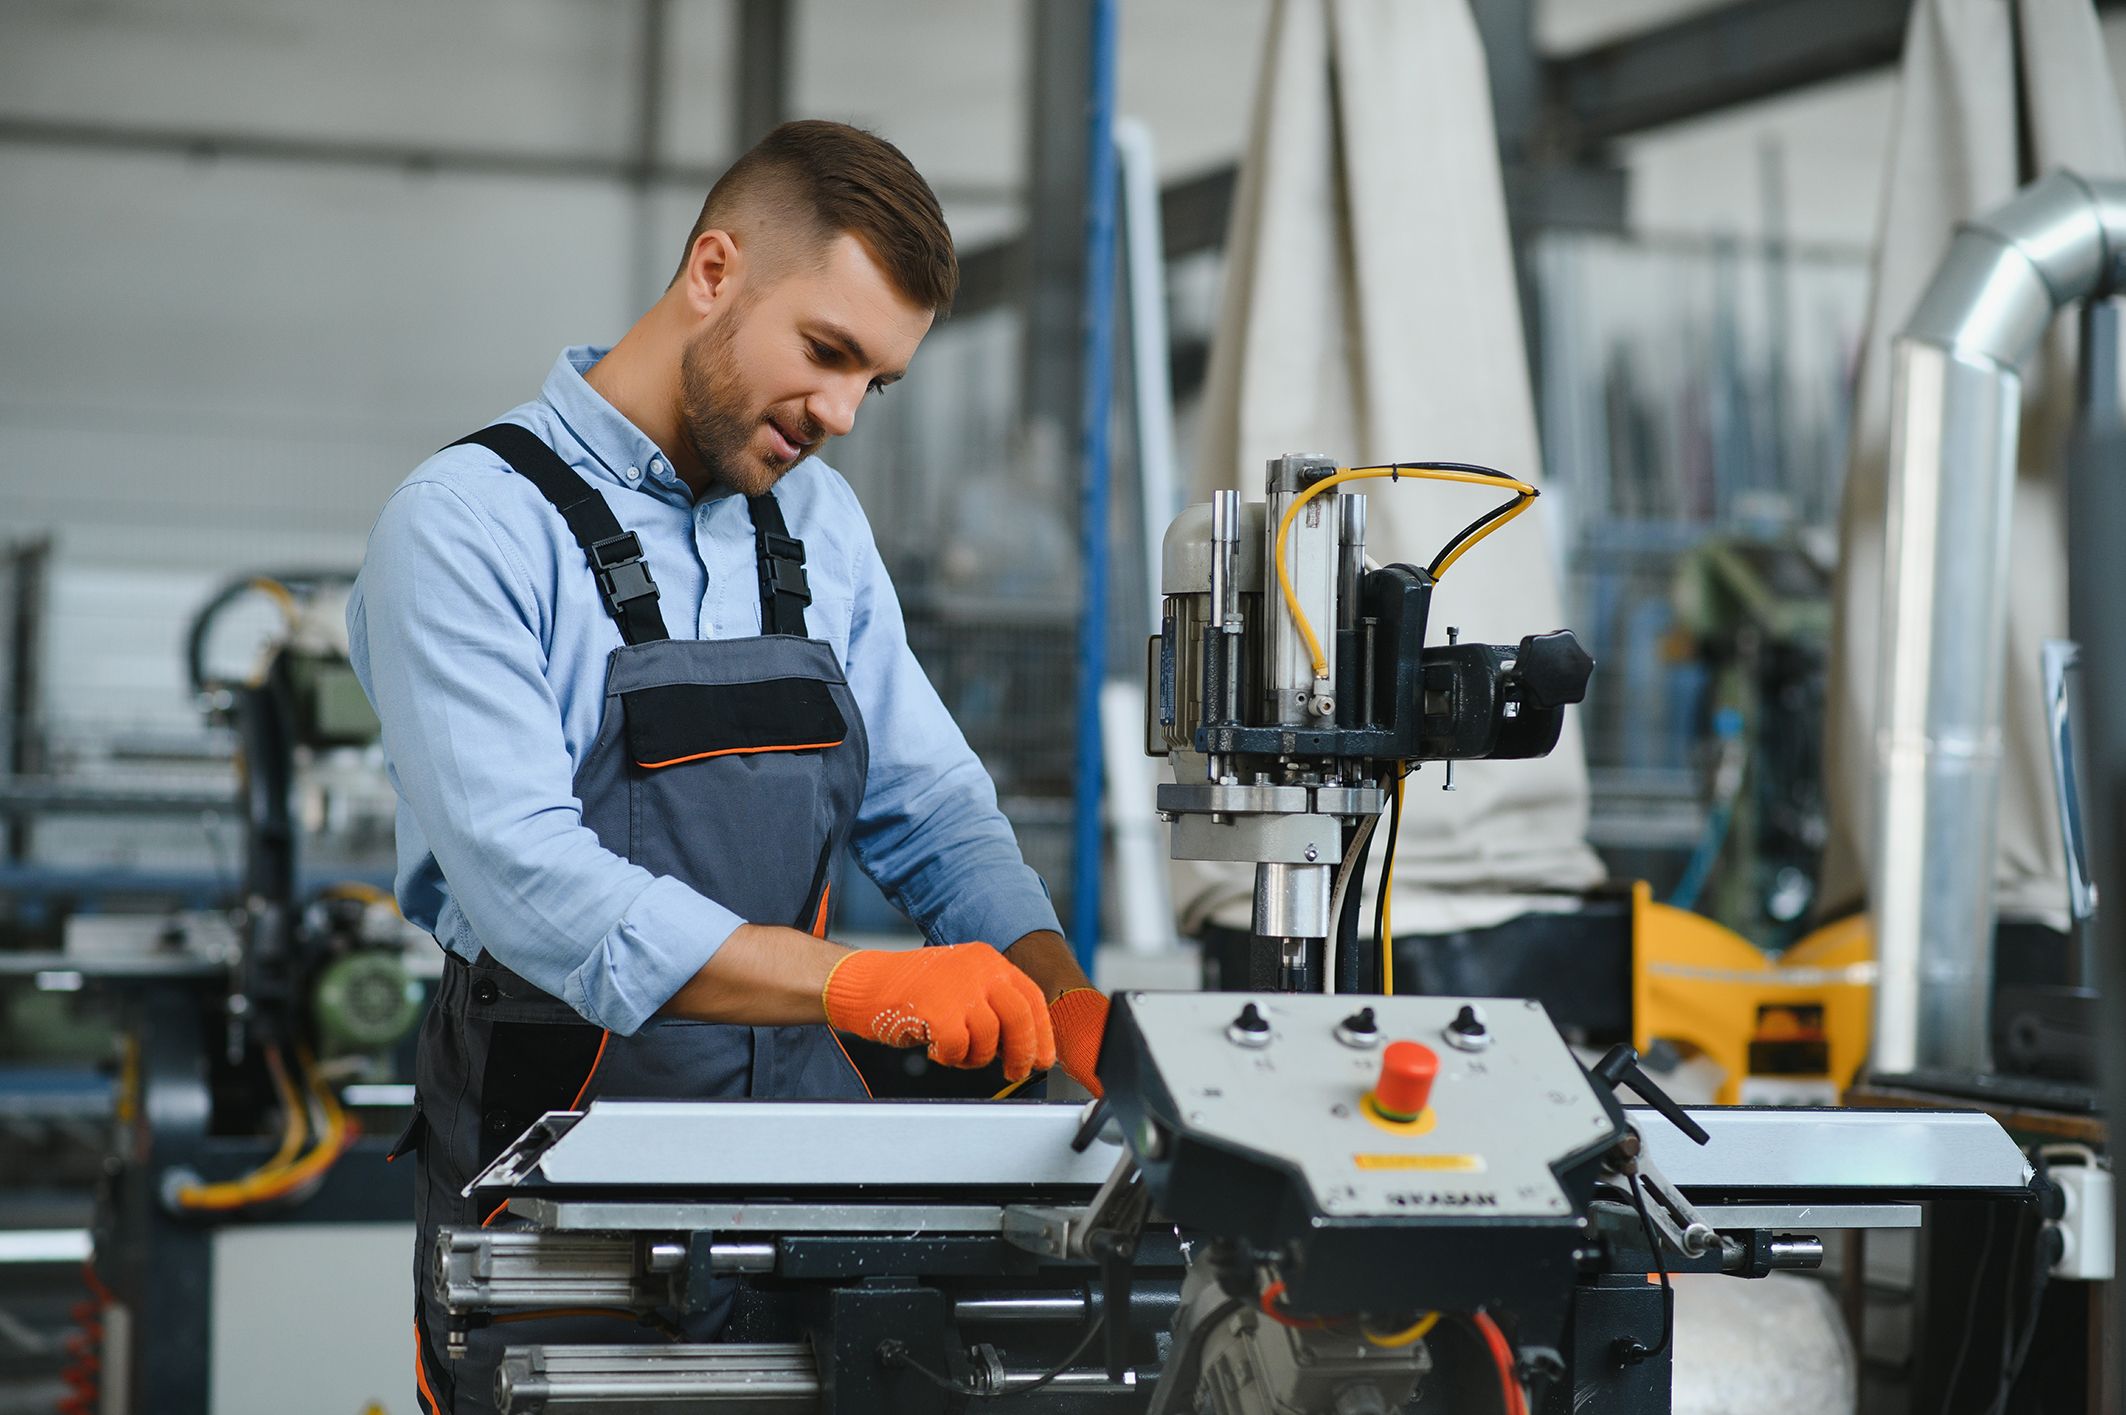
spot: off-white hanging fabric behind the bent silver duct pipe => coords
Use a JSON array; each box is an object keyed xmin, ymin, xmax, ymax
[{"xmin": 1820, "ymin": 0, "xmax": 2126, "ymax": 928}]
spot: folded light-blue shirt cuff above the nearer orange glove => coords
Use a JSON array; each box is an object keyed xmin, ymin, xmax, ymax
[{"xmin": 561, "ymin": 875, "xmax": 746, "ymax": 1037}]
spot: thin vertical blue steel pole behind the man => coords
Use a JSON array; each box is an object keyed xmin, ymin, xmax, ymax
[{"xmin": 1069, "ymin": 0, "xmax": 1118, "ymax": 975}]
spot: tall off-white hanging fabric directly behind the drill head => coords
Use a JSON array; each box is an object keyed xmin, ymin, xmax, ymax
[{"xmin": 1174, "ymin": 0, "xmax": 1603, "ymax": 933}]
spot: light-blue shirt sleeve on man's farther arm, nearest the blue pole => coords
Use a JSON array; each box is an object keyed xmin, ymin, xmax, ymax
[{"xmin": 844, "ymin": 518, "xmax": 1061, "ymax": 948}]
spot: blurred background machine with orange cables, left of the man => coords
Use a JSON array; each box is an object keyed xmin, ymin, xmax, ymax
[{"xmin": 0, "ymin": 574, "xmax": 440, "ymax": 1415}]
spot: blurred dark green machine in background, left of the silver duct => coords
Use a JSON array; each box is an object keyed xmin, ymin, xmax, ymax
[{"xmin": 1669, "ymin": 535, "xmax": 1830, "ymax": 950}]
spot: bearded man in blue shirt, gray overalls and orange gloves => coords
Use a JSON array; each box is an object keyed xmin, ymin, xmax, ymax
[{"xmin": 349, "ymin": 123, "xmax": 1108, "ymax": 1415}]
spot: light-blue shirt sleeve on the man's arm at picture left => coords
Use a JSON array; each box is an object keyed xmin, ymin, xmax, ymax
[{"xmin": 349, "ymin": 480, "xmax": 744, "ymax": 1035}]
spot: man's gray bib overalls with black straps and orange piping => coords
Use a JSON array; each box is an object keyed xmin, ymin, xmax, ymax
[{"xmin": 393, "ymin": 423, "xmax": 867, "ymax": 1415}]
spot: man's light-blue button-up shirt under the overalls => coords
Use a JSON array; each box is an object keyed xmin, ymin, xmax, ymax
[{"xmin": 347, "ymin": 348, "xmax": 1057, "ymax": 1035}]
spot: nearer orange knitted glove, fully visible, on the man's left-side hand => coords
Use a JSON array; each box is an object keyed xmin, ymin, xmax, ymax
[{"xmin": 821, "ymin": 943, "xmax": 1057, "ymax": 1081}]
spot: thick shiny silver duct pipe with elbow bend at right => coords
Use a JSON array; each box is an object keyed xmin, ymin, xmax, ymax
[{"xmin": 1869, "ymin": 172, "xmax": 2126, "ymax": 1073}]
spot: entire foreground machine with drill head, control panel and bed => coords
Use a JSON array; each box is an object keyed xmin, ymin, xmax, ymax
[{"xmin": 429, "ymin": 457, "xmax": 2030, "ymax": 1415}]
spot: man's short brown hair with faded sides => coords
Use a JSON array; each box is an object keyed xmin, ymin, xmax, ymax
[{"xmin": 672, "ymin": 119, "xmax": 959, "ymax": 314}]
